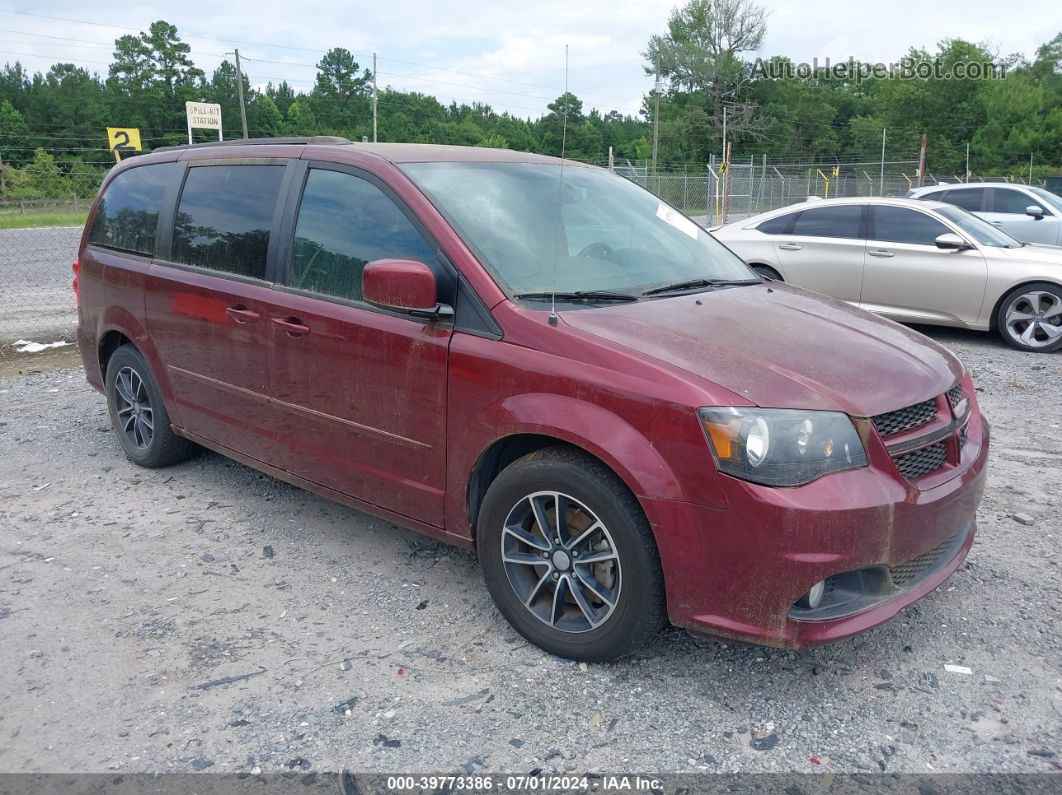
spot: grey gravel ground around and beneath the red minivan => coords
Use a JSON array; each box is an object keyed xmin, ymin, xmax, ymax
[{"xmin": 0, "ymin": 329, "xmax": 1062, "ymax": 773}]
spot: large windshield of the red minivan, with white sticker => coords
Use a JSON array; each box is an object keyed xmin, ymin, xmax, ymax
[{"xmin": 401, "ymin": 162, "xmax": 760, "ymax": 301}]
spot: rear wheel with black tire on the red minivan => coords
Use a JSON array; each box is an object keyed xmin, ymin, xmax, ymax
[{"xmin": 104, "ymin": 345, "xmax": 199, "ymax": 469}]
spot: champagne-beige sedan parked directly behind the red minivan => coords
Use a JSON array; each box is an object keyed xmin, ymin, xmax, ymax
[{"xmin": 712, "ymin": 198, "xmax": 1062, "ymax": 352}]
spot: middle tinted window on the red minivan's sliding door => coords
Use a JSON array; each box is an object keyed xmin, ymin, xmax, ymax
[{"xmin": 172, "ymin": 166, "xmax": 285, "ymax": 279}]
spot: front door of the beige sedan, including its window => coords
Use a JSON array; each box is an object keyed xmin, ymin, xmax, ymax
[{"xmin": 859, "ymin": 205, "xmax": 988, "ymax": 324}]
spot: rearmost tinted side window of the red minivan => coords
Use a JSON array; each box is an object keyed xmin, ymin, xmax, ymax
[{"xmin": 88, "ymin": 162, "xmax": 182, "ymax": 257}]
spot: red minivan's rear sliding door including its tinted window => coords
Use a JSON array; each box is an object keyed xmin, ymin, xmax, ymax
[{"xmin": 145, "ymin": 163, "xmax": 287, "ymax": 464}]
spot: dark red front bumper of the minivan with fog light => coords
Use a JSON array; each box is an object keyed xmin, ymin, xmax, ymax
[{"xmin": 644, "ymin": 415, "xmax": 989, "ymax": 649}]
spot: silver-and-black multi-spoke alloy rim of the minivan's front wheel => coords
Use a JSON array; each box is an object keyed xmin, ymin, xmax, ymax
[{"xmin": 501, "ymin": 491, "xmax": 621, "ymax": 633}]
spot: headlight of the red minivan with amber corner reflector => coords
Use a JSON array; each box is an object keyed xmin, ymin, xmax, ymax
[{"xmin": 700, "ymin": 408, "xmax": 867, "ymax": 486}]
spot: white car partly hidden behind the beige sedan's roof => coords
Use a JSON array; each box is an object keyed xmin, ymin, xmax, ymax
[{"xmin": 907, "ymin": 183, "xmax": 1062, "ymax": 245}]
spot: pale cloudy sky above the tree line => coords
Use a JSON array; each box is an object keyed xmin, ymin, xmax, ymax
[{"xmin": 0, "ymin": 0, "xmax": 1062, "ymax": 117}]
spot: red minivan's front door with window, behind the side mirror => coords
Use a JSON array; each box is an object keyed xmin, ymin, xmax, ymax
[{"xmin": 266, "ymin": 167, "xmax": 450, "ymax": 526}]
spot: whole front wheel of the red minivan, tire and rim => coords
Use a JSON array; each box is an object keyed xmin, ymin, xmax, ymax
[{"xmin": 477, "ymin": 447, "xmax": 664, "ymax": 662}]
